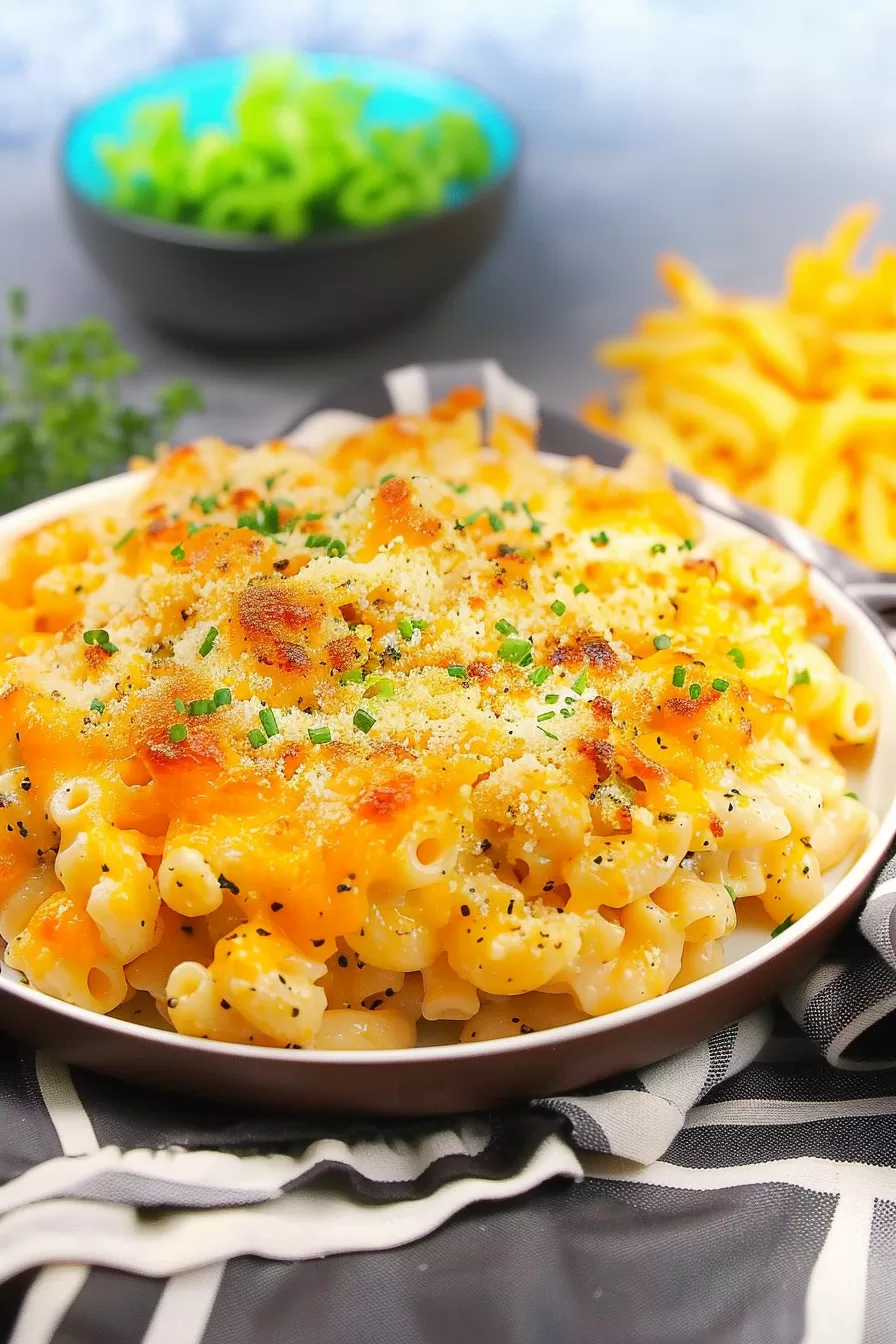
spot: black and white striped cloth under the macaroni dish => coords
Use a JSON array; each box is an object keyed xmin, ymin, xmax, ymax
[{"xmin": 0, "ymin": 364, "xmax": 896, "ymax": 1344}]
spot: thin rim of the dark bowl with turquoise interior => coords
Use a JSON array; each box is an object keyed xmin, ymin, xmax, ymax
[{"xmin": 54, "ymin": 48, "xmax": 525, "ymax": 255}]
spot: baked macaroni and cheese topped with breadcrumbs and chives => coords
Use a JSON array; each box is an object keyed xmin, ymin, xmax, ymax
[{"xmin": 0, "ymin": 390, "xmax": 876, "ymax": 1050}]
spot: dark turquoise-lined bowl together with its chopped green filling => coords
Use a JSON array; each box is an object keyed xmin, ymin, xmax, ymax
[{"xmin": 59, "ymin": 54, "xmax": 520, "ymax": 345}]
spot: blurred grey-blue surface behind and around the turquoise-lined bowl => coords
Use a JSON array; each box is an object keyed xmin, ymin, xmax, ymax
[{"xmin": 0, "ymin": 0, "xmax": 896, "ymax": 441}]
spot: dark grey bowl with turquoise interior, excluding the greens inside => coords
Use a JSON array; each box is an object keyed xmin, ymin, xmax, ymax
[{"xmin": 60, "ymin": 55, "xmax": 520, "ymax": 347}]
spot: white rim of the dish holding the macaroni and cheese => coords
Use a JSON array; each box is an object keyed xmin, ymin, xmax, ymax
[{"xmin": 0, "ymin": 453, "xmax": 896, "ymax": 1068}]
